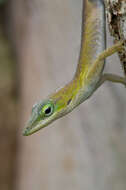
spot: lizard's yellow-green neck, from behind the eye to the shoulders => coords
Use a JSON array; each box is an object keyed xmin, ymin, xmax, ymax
[{"xmin": 49, "ymin": 78, "xmax": 95, "ymax": 117}]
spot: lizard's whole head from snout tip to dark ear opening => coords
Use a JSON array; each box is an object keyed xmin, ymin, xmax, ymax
[{"xmin": 23, "ymin": 82, "xmax": 75, "ymax": 136}]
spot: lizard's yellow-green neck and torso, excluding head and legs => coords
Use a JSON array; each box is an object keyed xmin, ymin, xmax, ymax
[{"xmin": 51, "ymin": 0, "xmax": 105, "ymax": 112}]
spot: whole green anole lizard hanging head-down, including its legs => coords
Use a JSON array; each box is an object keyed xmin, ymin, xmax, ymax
[{"xmin": 23, "ymin": 0, "xmax": 126, "ymax": 136}]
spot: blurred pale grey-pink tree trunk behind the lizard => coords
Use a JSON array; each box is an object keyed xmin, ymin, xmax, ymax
[{"xmin": 8, "ymin": 0, "xmax": 126, "ymax": 190}]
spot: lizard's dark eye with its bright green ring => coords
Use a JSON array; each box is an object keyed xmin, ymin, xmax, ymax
[{"xmin": 41, "ymin": 103, "xmax": 54, "ymax": 117}]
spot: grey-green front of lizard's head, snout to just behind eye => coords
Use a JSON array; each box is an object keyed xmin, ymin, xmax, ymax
[{"xmin": 23, "ymin": 100, "xmax": 58, "ymax": 136}]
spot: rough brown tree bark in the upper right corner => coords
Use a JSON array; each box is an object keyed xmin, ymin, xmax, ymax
[{"xmin": 106, "ymin": 0, "xmax": 126, "ymax": 75}]
